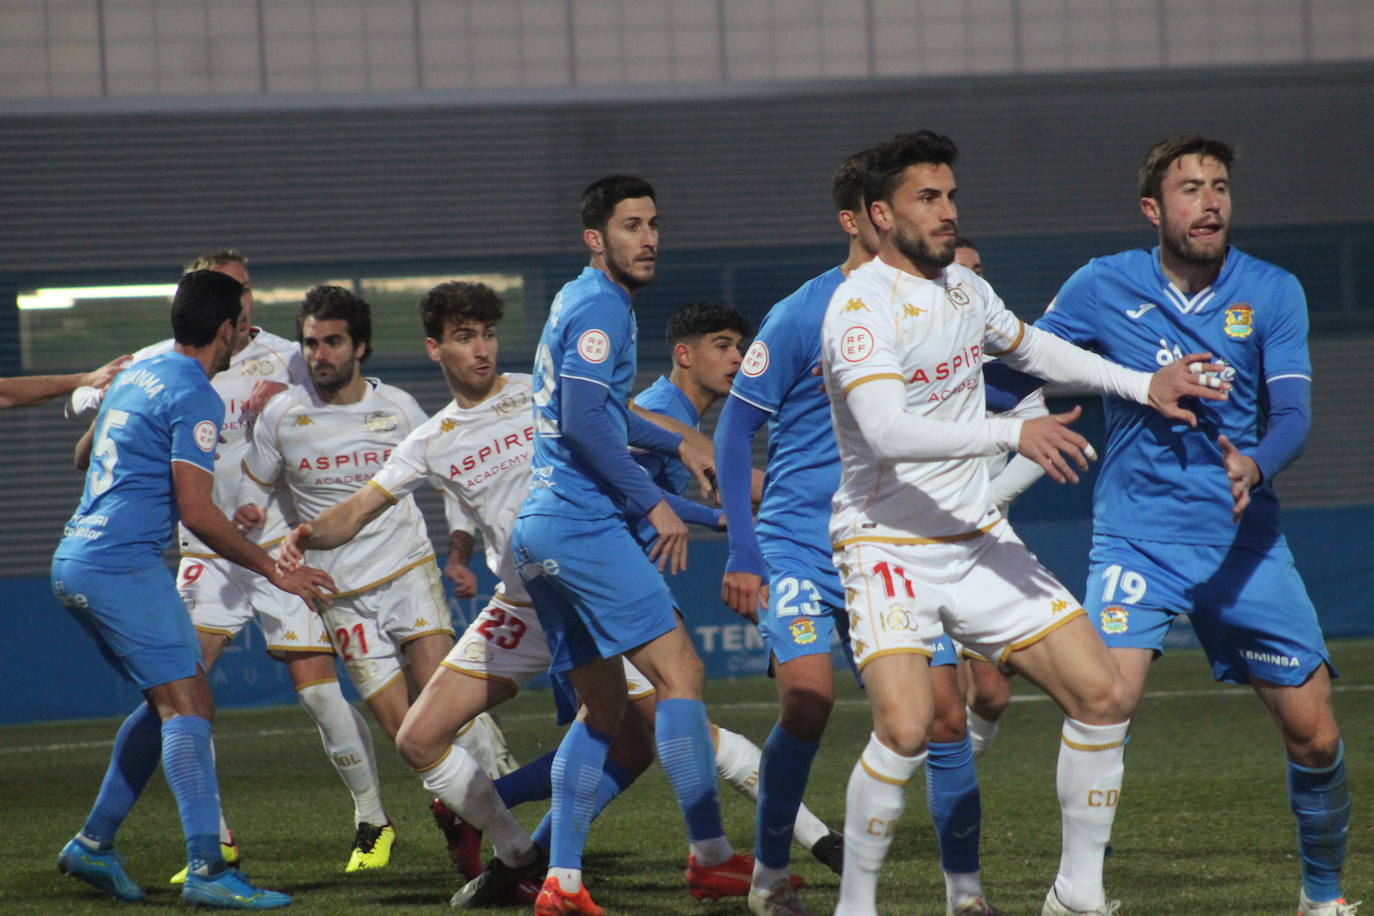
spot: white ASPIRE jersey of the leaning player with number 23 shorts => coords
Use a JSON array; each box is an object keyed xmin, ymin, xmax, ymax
[{"xmin": 371, "ymin": 372, "xmax": 534, "ymax": 603}]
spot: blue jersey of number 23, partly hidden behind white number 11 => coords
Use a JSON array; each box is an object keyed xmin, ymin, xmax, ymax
[{"xmin": 730, "ymin": 268, "xmax": 845, "ymax": 556}]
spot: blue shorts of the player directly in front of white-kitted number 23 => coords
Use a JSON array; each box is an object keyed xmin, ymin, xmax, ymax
[{"xmin": 511, "ymin": 515, "xmax": 677, "ymax": 672}]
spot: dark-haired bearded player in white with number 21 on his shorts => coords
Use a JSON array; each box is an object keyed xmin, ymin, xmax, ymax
[{"xmin": 235, "ymin": 286, "xmax": 453, "ymax": 867}]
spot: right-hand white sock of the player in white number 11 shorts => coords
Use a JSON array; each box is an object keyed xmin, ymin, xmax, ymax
[{"xmin": 1049, "ymin": 718, "xmax": 1131, "ymax": 911}]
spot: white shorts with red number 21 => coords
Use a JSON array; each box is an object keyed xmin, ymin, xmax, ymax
[{"xmin": 323, "ymin": 563, "xmax": 453, "ymax": 699}]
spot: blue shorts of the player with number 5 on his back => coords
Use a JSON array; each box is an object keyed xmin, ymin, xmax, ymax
[{"xmin": 52, "ymin": 559, "xmax": 201, "ymax": 689}]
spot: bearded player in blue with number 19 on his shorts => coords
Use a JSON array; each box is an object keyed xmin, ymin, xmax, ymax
[{"xmin": 1037, "ymin": 136, "xmax": 1358, "ymax": 916}]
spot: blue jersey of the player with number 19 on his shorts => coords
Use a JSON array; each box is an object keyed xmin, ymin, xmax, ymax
[{"xmin": 1036, "ymin": 247, "xmax": 1312, "ymax": 545}]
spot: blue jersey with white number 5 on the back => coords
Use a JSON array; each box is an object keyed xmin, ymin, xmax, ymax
[{"xmin": 55, "ymin": 352, "xmax": 224, "ymax": 567}]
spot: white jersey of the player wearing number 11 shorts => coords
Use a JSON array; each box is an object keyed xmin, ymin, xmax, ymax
[{"xmin": 822, "ymin": 258, "xmax": 1024, "ymax": 548}]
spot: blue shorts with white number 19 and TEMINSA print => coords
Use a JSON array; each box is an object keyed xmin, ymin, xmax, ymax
[{"xmin": 1083, "ymin": 534, "xmax": 1336, "ymax": 687}]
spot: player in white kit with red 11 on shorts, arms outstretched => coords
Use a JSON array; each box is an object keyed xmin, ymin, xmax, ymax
[{"xmin": 822, "ymin": 130, "xmax": 1224, "ymax": 916}]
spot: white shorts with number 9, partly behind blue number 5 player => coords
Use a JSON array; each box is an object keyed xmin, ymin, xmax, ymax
[{"xmin": 176, "ymin": 556, "xmax": 334, "ymax": 658}]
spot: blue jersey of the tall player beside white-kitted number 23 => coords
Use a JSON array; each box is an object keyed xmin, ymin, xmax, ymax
[{"xmin": 521, "ymin": 266, "xmax": 638, "ymax": 519}]
